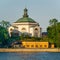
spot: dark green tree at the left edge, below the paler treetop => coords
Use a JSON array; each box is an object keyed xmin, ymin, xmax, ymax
[{"xmin": 0, "ymin": 26, "xmax": 9, "ymax": 46}]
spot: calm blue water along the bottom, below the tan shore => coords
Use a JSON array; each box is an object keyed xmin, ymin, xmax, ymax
[{"xmin": 0, "ymin": 53, "xmax": 60, "ymax": 60}]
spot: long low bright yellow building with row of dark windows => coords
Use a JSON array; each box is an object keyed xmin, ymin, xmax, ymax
[{"xmin": 22, "ymin": 41, "xmax": 49, "ymax": 48}]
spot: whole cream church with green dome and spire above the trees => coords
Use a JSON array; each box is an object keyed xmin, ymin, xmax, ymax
[{"xmin": 8, "ymin": 8, "xmax": 41, "ymax": 37}]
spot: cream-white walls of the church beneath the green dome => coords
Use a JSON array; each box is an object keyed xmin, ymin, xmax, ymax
[{"xmin": 8, "ymin": 23, "xmax": 41, "ymax": 37}]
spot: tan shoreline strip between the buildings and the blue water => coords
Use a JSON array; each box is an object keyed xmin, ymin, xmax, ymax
[{"xmin": 0, "ymin": 48, "xmax": 60, "ymax": 52}]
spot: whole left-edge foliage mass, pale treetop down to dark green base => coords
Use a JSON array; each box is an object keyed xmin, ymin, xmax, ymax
[{"xmin": 0, "ymin": 20, "xmax": 11, "ymax": 47}]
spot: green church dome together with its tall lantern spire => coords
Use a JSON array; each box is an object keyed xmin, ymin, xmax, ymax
[{"xmin": 15, "ymin": 8, "xmax": 36, "ymax": 23}]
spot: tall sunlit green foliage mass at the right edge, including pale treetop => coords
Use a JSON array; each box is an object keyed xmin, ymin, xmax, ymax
[{"xmin": 47, "ymin": 19, "xmax": 60, "ymax": 47}]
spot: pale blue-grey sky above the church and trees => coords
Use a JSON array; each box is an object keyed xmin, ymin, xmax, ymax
[{"xmin": 0, "ymin": 0, "xmax": 60, "ymax": 31}]
